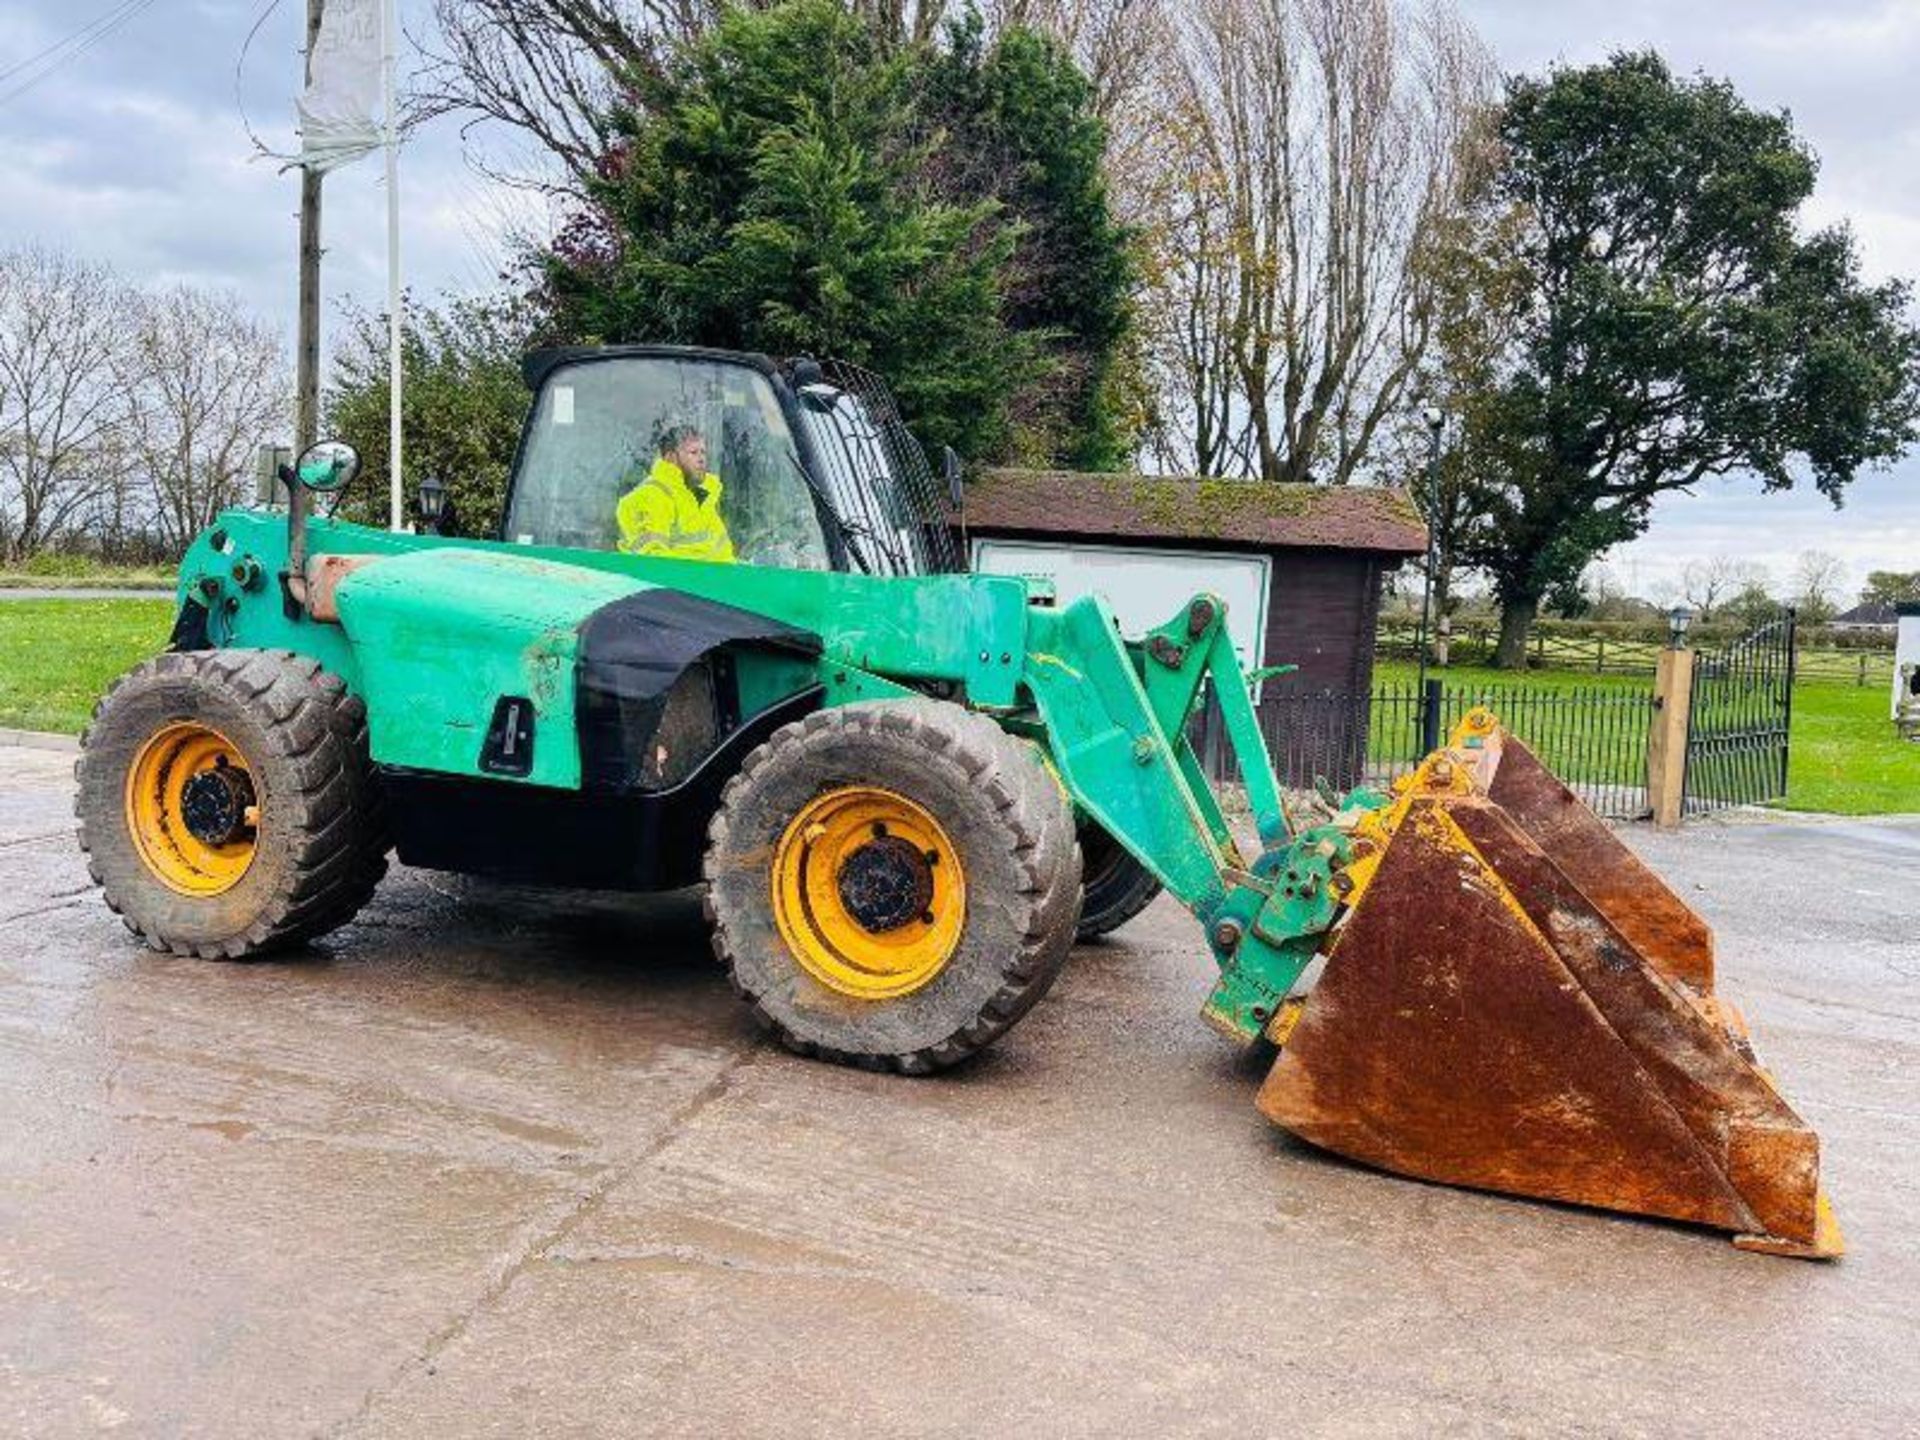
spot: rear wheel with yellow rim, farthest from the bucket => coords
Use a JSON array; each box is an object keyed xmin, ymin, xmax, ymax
[{"xmin": 75, "ymin": 649, "xmax": 388, "ymax": 960}]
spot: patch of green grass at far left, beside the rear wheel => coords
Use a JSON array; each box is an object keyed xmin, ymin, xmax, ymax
[{"xmin": 0, "ymin": 599, "xmax": 173, "ymax": 735}]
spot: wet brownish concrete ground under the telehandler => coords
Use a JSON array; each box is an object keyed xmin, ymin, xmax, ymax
[{"xmin": 0, "ymin": 749, "xmax": 1920, "ymax": 1438}]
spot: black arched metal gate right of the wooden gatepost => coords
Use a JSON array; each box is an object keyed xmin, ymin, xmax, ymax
[{"xmin": 1684, "ymin": 611, "xmax": 1795, "ymax": 814}]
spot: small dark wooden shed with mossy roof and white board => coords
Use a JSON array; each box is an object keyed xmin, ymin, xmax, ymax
[{"xmin": 966, "ymin": 470, "xmax": 1427, "ymax": 783}]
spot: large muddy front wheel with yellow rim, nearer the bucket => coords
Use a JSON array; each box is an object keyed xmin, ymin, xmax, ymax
[{"xmin": 705, "ymin": 699, "xmax": 1081, "ymax": 1075}]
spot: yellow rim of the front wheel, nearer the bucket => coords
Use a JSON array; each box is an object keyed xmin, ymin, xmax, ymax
[{"xmin": 772, "ymin": 785, "xmax": 966, "ymax": 1000}]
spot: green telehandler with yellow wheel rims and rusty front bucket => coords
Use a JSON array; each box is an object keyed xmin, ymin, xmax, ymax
[{"xmin": 77, "ymin": 346, "xmax": 1839, "ymax": 1256}]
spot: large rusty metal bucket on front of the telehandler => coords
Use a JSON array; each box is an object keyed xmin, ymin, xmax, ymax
[{"xmin": 1258, "ymin": 718, "xmax": 1841, "ymax": 1256}]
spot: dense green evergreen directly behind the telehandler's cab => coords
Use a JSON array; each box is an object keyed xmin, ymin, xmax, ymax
[{"xmin": 543, "ymin": 0, "xmax": 1125, "ymax": 459}]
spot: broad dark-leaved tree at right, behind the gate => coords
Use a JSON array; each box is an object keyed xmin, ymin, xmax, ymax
[{"xmin": 1461, "ymin": 54, "xmax": 1920, "ymax": 666}]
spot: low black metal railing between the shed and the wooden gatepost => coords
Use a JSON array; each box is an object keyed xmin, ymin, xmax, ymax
[{"xmin": 1188, "ymin": 680, "xmax": 1653, "ymax": 820}]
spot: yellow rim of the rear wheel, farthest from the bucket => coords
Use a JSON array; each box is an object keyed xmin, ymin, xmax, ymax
[{"xmin": 127, "ymin": 720, "xmax": 259, "ymax": 897}]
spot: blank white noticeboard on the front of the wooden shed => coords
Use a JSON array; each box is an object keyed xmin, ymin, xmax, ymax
[{"xmin": 973, "ymin": 540, "xmax": 1273, "ymax": 670}]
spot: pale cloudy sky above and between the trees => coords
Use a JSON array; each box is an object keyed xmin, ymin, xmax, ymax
[{"xmin": 0, "ymin": 0, "xmax": 1920, "ymax": 591}]
